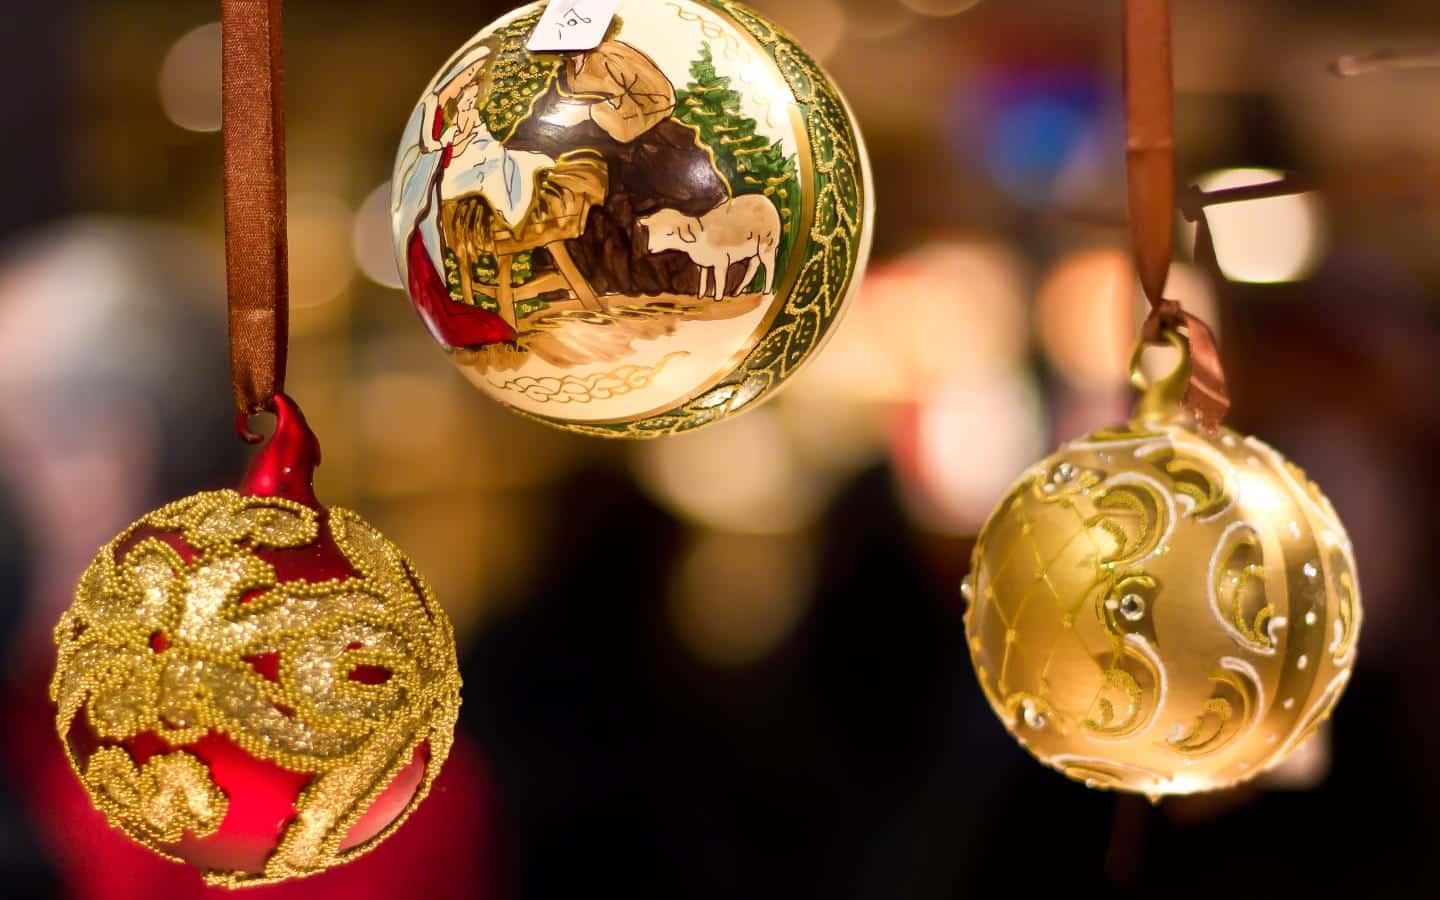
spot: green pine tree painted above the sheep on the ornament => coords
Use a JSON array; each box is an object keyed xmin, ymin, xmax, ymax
[{"xmin": 675, "ymin": 43, "xmax": 801, "ymax": 291}]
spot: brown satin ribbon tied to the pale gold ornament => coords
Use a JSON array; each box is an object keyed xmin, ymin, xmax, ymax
[{"xmin": 1125, "ymin": 0, "xmax": 1230, "ymax": 429}]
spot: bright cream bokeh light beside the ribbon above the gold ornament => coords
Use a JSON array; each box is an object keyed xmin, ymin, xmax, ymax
[{"xmin": 1197, "ymin": 168, "xmax": 1326, "ymax": 284}]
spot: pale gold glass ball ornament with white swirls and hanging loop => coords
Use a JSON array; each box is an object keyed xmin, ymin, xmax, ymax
[{"xmin": 963, "ymin": 331, "xmax": 1361, "ymax": 799}]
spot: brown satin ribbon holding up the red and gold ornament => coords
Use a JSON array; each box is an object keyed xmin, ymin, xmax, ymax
[{"xmin": 220, "ymin": 0, "xmax": 289, "ymax": 439}]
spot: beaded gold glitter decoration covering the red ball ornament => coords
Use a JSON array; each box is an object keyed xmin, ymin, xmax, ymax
[{"xmin": 50, "ymin": 491, "xmax": 459, "ymax": 886}]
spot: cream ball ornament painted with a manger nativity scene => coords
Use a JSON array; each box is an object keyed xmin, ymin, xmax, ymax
[{"xmin": 392, "ymin": 0, "xmax": 873, "ymax": 438}]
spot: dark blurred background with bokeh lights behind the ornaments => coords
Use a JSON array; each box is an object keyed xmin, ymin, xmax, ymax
[{"xmin": 0, "ymin": 0, "xmax": 1440, "ymax": 900}]
